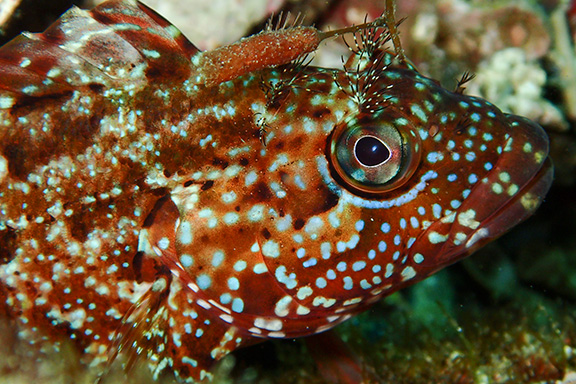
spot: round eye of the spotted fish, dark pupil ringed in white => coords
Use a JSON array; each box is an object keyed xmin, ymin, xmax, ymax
[{"xmin": 330, "ymin": 122, "xmax": 420, "ymax": 193}]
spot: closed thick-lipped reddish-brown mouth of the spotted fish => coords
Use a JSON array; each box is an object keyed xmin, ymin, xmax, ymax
[{"xmin": 410, "ymin": 115, "xmax": 554, "ymax": 271}]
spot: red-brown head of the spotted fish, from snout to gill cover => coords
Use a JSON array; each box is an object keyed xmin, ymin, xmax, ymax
[{"xmin": 154, "ymin": 55, "xmax": 552, "ymax": 337}]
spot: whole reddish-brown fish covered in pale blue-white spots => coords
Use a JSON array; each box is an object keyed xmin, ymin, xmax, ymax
[{"xmin": 0, "ymin": 0, "xmax": 553, "ymax": 382}]
